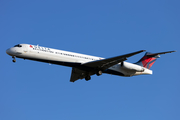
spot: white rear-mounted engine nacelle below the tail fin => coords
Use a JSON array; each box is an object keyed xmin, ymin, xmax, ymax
[{"xmin": 121, "ymin": 62, "xmax": 144, "ymax": 72}]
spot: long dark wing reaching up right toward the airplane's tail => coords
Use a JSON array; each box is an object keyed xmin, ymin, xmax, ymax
[{"xmin": 82, "ymin": 50, "xmax": 145, "ymax": 70}]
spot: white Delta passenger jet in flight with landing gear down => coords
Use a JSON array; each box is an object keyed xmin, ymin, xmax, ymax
[{"xmin": 6, "ymin": 44, "xmax": 176, "ymax": 82}]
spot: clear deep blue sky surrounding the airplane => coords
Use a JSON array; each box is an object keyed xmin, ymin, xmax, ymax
[{"xmin": 0, "ymin": 0, "xmax": 180, "ymax": 120}]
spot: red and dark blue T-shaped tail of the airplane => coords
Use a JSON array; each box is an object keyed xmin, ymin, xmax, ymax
[{"xmin": 135, "ymin": 51, "xmax": 176, "ymax": 69}]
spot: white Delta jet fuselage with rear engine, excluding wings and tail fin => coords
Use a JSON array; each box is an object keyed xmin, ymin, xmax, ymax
[{"xmin": 6, "ymin": 44, "xmax": 152, "ymax": 76}]
